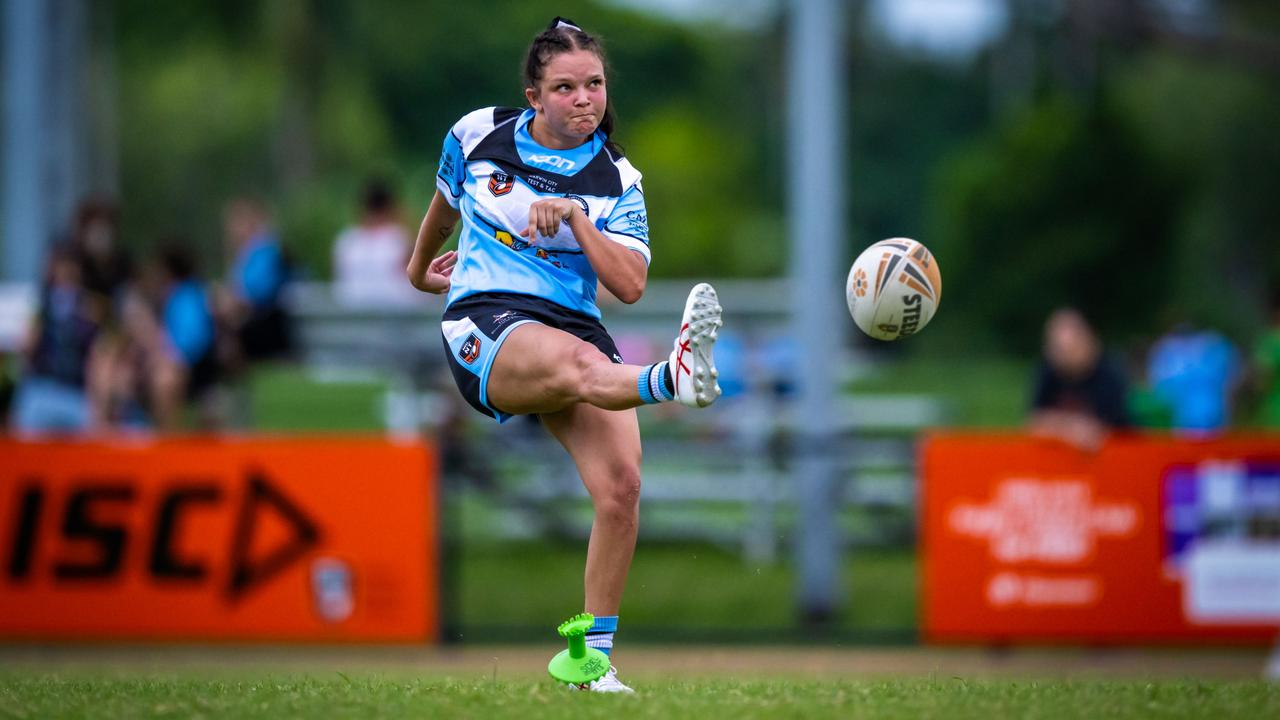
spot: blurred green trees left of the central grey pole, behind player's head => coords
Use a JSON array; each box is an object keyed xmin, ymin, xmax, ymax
[{"xmin": 113, "ymin": 0, "xmax": 768, "ymax": 277}]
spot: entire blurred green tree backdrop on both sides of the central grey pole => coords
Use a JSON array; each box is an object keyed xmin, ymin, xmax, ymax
[{"xmin": 102, "ymin": 0, "xmax": 1280, "ymax": 350}]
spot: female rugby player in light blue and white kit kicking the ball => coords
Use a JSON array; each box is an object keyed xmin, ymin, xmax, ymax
[{"xmin": 407, "ymin": 18, "xmax": 721, "ymax": 692}]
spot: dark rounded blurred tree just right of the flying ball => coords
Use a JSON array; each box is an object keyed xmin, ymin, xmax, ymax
[{"xmin": 937, "ymin": 96, "xmax": 1180, "ymax": 350}]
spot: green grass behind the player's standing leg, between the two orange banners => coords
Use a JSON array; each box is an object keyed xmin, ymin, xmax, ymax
[{"xmin": 456, "ymin": 541, "xmax": 918, "ymax": 642}]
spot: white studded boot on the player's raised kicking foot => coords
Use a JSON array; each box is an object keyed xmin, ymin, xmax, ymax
[{"xmin": 668, "ymin": 283, "xmax": 724, "ymax": 407}]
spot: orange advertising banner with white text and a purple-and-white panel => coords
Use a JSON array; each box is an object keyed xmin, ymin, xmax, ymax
[{"xmin": 920, "ymin": 434, "xmax": 1280, "ymax": 643}]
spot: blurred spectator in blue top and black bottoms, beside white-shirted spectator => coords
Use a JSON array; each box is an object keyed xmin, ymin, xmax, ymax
[{"xmin": 218, "ymin": 197, "xmax": 292, "ymax": 361}]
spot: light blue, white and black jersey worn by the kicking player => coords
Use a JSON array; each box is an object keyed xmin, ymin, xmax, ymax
[{"xmin": 435, "ymin": 108, "xmax": 649, "ymax": 318}]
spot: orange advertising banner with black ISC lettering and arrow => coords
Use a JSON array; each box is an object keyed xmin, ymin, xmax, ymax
[{"xmin": 0, "ymin": 437, "xmax": 438, "ymax": 642}]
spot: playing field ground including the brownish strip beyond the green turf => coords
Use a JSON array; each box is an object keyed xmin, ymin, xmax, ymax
[{"xmin": 0, "ymin": 648, "xmax": 1280, "ymax": 720}]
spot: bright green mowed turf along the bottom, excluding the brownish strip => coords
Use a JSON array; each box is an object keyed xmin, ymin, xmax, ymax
[{"xmin": 0, "ymin": 670, "xmax": 1280, "ymax": 720}]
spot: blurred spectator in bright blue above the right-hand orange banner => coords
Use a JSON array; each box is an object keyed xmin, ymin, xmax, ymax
[{"xmin": 1147, "ymin": 323, "xmax": 1240, "ymax": 432}]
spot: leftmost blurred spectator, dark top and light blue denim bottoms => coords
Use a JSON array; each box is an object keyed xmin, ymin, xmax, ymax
[{"xmin": 13, "ymin": 246, "xmax": 108, "ymax": 433}]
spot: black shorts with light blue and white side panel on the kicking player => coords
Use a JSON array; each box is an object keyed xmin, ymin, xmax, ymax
[{"xmin": 440, "ymin": 292, "xmax": 622, "ymax": 423}]
